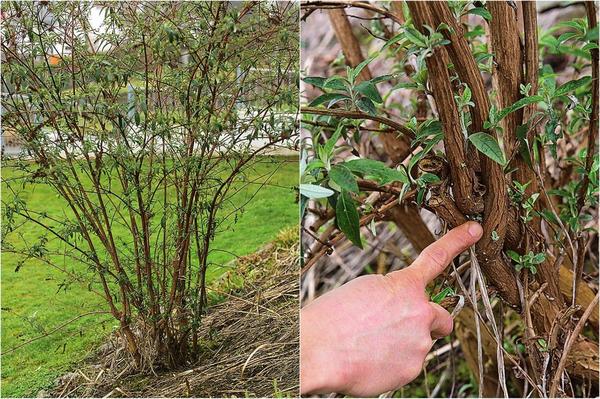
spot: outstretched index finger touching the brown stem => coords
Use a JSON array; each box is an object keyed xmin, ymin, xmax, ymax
[{"xmin": 405, "ymin": 222, "xmax": 483, "ymax": 285}]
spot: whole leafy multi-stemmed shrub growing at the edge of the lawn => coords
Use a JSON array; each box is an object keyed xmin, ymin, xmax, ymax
[{"xmin": 2, "ymin": 2, "xmax": 298, "ymax": 368}]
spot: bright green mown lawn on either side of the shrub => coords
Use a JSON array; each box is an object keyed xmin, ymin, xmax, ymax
[{"xmin": 0, "ymin": 158, "xmax": 298, "ymax": 397}]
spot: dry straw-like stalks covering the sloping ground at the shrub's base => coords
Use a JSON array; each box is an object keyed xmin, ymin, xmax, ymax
[{"xmin": 50, "ymin": 230, "xmax": 299, "ymax": 397}]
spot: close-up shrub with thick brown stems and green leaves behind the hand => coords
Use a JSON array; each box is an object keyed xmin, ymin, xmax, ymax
[{"xmin": 301, "ymin": 1, "xmax": 598, "ymax": 397}]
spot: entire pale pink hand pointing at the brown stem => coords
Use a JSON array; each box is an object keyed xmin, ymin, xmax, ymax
[{"xmin": 300, "ymin": 222, "xmax": 482, "ymax": 397}]
